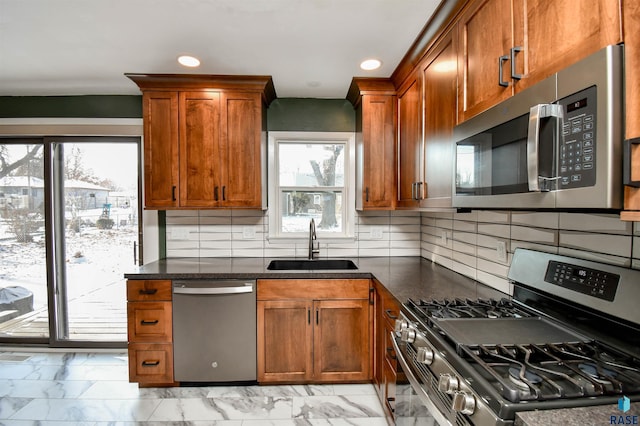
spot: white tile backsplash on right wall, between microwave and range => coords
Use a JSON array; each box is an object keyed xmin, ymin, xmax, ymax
[{"xmin": 421, "ymin": 210, "xmax": 640, "ymax": 294}]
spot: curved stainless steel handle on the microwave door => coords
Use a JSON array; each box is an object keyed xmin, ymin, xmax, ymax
[{"xmin": 527, "ymin": 104, "xmax": 564, "ymax": 192}]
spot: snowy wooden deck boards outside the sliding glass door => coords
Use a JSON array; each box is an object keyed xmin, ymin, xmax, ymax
[{"xmin": 0, "ymin": 283, "xmax": 127, "ymax": 342}]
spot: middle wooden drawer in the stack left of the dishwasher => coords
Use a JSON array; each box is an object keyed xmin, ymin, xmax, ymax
[{"xmin": 127, "ymin": 302, "xmax": 173, "ymax": 343}]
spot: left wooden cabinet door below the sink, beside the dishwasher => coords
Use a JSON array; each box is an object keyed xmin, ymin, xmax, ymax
[{"xmin": 258, "ymin": 300, "xmax": 313, "ymax": 383}]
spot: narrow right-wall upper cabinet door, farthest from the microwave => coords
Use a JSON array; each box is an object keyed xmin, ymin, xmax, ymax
[{"xmin": 397, "ymin": 75, "xmax": 423, "ymax": 211}]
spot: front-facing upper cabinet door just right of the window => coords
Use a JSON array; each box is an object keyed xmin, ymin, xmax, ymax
[{"xmin": 359, "ymin": 95, "xmax": 396, "ymax": 209}]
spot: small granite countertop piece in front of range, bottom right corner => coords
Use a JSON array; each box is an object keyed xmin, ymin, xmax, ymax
[{"xmin": 515, "ymin": 402, "xmax": 640, "ymax": 426}]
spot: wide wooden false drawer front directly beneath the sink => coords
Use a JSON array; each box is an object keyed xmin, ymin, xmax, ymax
[{"xmin": 258, "ymin": 279, "xmax": 371, "ymax": 300}]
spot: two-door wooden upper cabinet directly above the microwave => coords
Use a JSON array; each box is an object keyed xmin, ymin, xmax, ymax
[{"xmin": 456, "ymin": 0, "xmax": 622, "ymax": 122}]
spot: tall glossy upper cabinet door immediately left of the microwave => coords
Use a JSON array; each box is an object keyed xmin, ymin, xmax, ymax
[{"xmin": 420, "ymin": 31, "xmax": 457, "ymax": 208}]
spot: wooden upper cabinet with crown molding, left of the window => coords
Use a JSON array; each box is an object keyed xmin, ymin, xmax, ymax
[{"xmin": 127, "ymin": 74, "xmax": 275, "ymax": 209}]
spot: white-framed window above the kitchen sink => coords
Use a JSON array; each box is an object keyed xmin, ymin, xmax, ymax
[{"xmin": 269, "ymin": 132, "xmax": 354, "ymax": 238}]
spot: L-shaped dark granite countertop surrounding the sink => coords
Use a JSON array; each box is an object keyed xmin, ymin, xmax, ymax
[{"xmin": 125, "ymin": 257, "xmax": 506, "ymax": 302}]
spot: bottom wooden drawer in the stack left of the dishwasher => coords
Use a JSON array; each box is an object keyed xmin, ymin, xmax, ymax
[{"xmin": 129, "ymin": 343, "xmax": 173, "ymax": 384}]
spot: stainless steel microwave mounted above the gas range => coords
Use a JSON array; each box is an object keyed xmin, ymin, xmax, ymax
[{"xmin": 453, "ymin": 45, "xmax": 624, "ymax": 209}]
